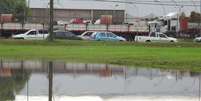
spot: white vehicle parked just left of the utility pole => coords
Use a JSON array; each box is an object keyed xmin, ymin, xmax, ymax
[{"xmin": 12, "ymin": 29, "xmax": 48, "ymax": 40}]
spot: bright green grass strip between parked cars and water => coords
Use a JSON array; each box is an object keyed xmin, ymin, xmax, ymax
[{"xmin": 0, "ymin": 40, "xmax": 201, "ymax": 71}]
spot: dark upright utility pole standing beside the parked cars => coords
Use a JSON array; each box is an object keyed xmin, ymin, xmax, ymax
[{"xmin": 48, "ymin": 0, "xmax": 54, "ymax": 41}]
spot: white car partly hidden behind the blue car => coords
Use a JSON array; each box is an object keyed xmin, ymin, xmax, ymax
[{"xmin": 78, "ymin": 31, "xmax": 95, "ymax": 40}]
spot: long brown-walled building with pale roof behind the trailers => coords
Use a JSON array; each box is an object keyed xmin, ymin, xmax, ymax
[{"xmin": 28, "ymin": 0, "xmax": 125, "ymax": 24}]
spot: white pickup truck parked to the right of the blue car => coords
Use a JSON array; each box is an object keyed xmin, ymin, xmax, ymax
[{"xmin": 135, "ymin": 32, "xmax": 178, "ymax": 42}]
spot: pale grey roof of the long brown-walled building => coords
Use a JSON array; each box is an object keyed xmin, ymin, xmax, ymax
[{"xmin": 29, "ymin": 0, "xmax": 125, "ymax": 10}]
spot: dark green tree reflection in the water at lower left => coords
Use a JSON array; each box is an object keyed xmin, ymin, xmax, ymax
[{"xmin": 0, "ymin": 69, "xmax": 30, "ymax": 101}]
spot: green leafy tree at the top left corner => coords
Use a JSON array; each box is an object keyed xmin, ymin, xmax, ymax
[{"xmin": 0, "ymin": 0, "xmax": 29, "ymax": 22}]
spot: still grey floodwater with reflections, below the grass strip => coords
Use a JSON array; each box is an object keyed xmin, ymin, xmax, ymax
[{"xmin": 0, "ymin": 60, "xmax": 201, "ymax": 101}]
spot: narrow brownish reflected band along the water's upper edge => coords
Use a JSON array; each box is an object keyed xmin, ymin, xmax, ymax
[{"xmin": 0, "ymin": 61, "xmax": 199, "ymax": 80}]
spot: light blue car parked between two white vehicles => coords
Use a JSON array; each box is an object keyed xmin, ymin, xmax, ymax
[{"xmin": 91, "ymin": 32, "xmax": 126, "ymax": 41}]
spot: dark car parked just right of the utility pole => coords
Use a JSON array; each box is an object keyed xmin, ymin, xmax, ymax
[{"xmin": 54, "ymin": 30, "xmax": 81, "ymax": 40}]
